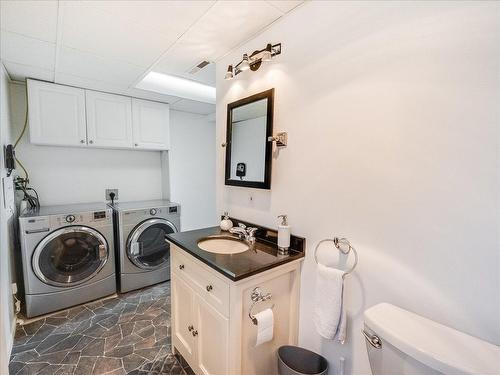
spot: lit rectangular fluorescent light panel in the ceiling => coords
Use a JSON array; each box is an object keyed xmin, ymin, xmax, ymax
[{"xmin": 135, "ymin": 72, "xmax": 215, "ymax": 104}]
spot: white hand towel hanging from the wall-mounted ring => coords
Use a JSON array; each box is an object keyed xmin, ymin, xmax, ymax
[{"xmin": 313, "ymin": 264, "xmax": 347, "ymax": 344}]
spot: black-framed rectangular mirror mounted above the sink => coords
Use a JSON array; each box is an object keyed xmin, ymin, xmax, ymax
[{"xmin": 226, "ymin": 89, "xmax": 274, "ymax": 189}]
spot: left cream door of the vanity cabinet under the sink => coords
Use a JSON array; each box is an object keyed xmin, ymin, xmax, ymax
[{"xmin": 171, "ymin": 272, "xmax": 196, "ymax": 364}]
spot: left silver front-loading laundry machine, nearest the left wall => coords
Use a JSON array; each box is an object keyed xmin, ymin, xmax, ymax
[{"xmin": 19, "ymin": 203, "xmax": 116, "ymax": 318}]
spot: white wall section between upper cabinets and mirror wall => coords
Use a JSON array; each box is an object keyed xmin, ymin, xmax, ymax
[{"xmin": 169, "ymin": 111, "xmax": 218, "ymax": 231}]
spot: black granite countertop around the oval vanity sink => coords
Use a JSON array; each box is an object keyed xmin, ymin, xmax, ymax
[{"xmin": 168, "ymin": 227, "xmax": 304, "ymax": 281}]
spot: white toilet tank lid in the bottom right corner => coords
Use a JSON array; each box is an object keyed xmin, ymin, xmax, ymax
[{"xmin": 365, "ymin": 303, "xmax": 500, "ymax": 375}]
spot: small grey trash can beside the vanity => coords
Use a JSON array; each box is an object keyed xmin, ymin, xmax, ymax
[{"xmin": 278, "ymin": 345, "xmax": 328, "ymax": 375}]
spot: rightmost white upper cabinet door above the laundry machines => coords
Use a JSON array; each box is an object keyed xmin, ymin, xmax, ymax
[{"xmin": 132, "ymin": 99, "xmax": 170, "ymax": 150}]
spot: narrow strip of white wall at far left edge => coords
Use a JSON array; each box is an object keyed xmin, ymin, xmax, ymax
[{"xmin": 0, "ymin": 63, "xmax": 15, "ymax": 374}]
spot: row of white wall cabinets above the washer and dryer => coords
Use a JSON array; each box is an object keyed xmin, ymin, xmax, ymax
[{"xmin": 27, "ymin": 79, "xmax": 170, "ymax": 150}]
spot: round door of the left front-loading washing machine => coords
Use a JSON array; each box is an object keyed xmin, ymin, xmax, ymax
[{"xmin": 32, "ymin": 226, "xmax": 109, "ymax": 287}]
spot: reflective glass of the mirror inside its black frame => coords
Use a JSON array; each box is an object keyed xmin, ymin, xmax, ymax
[{"xmin": 231, "ymin": 99, "xmax": 267, "ymax": 182}]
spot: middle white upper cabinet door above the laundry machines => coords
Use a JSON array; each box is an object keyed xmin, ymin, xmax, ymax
[{"xmin": 85, "ymin": 90, "xmax": 132, "ymax": 148}]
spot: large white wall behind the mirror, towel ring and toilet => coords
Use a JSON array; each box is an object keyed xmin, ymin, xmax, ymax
[{"xmin": 217, "ymin": 1, "xmax": 500, "ymax": 375}]
